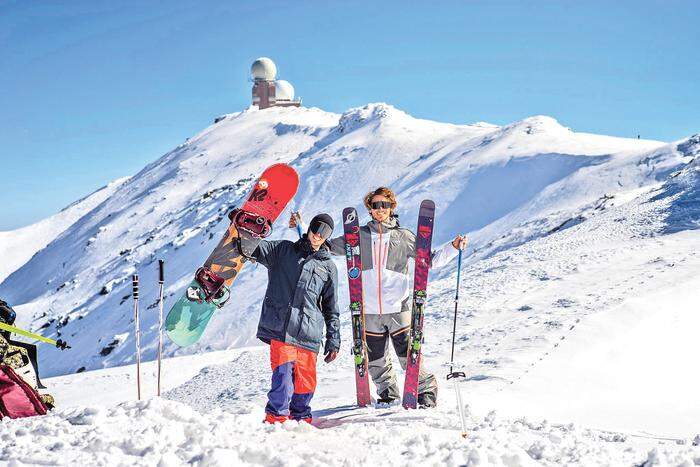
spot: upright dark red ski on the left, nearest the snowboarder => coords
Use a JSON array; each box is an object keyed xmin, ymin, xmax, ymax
[{"xmin": 343, "ymin": 208, "xmax": 372, "ymax": 407}]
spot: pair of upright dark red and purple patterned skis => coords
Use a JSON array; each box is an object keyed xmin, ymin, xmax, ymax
[{"xmin": 343, "ymin": 200, "xmax": 435, "ymax": 409}]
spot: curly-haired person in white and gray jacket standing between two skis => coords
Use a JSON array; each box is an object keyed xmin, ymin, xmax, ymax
[{"xmin": 296, "ymin": 187, "xmax": 467, "ymax": 407}]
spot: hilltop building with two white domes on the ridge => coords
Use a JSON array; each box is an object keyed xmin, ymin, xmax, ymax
[{"xmin": 250, "ymin": 57, "xmax": 301, "ymax": 110}]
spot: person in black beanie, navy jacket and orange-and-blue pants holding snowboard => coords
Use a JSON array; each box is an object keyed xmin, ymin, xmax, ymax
[{"xmin": 253, "ymin": 214, "xmax": 340, "ymax": 423}]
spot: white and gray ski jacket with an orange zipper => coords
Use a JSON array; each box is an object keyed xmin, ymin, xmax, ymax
[{"xmin": 328, "ymin": 218, "xmax": 458, "ymax": 315}]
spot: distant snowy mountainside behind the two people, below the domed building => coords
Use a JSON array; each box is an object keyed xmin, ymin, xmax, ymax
[{"xmin": 0, "ymin": 104, "xmax": 692, "ymax": 388}]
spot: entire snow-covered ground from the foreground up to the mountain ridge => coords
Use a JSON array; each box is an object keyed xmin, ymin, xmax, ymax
[{"xmin": 0, "ymin": 104, "xmax": 700, "ymax": 466}]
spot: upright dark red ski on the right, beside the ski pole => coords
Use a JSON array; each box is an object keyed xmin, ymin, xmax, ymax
[{"xmin": 403, "ymin": 200, "xmax": 435, "ymax": 409}]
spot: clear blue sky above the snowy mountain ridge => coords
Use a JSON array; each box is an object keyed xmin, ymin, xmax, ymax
[{"xmin": 0, "ymin": 0, "xmax": 700, "ymax": 230}]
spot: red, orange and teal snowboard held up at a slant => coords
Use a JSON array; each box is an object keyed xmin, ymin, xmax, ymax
[{"xmin": 165, "ymin": 164, "xmax": 299, "ymax": 347}]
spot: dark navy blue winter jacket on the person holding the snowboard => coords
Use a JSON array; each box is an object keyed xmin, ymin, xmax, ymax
[{"xmin": 253, "ymin": 236, "xmax": 340, "ymax": 352}]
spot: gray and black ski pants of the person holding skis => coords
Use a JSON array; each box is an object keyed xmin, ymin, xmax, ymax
[{"xmin": 365, "ymin": 311, "xmax": 437, "ymax": 399}]
